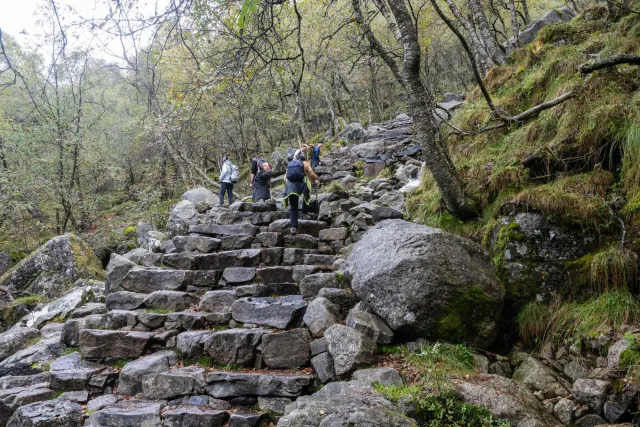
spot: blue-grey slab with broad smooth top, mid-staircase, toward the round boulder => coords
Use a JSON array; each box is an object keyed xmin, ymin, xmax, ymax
[{"xmin": 231, "ymin": 295, "xmax": 307, "ymax": 329}]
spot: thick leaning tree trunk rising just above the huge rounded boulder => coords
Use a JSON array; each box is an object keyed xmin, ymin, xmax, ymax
[{"xmin": 388, "ymin": 0, "xmax": 477, "ymax": 219}]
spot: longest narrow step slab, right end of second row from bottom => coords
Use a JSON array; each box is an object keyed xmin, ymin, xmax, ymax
[{"xmin": 207, "ymin": 371, "xmax": 313, "ymax": 399}]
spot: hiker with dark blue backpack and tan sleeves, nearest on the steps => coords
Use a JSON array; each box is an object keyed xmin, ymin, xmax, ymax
[{"xmin": 283, "ymin": 152, "xmax": 319, "ymax": 234}]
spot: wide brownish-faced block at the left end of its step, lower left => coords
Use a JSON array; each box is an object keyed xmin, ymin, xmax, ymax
[{"xmin": 80, "ymin": 329, "xmax": 153, "ymax": 359}]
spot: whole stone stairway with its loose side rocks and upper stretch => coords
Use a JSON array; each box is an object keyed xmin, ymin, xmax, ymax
[{"xmin": 0, "ymin": 114, "xmax": 430, "ymax": 427}]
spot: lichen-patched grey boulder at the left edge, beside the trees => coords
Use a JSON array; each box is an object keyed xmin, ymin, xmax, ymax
[{"xmin": 0, "ymin": 234, "xmax": 104, "ymax": 298}]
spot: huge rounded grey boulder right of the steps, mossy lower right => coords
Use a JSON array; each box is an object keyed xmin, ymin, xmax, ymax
[{"xmin": 343, "ymin": 220, "xmax": 504, "ymax": 348}]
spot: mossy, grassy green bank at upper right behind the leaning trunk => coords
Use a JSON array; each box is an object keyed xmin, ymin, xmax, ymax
[{"xmin": 407, "ymin": 5, "xmax": 640, "ymax": 243}]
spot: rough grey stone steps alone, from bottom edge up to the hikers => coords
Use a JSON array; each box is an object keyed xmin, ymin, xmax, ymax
[{"xmin": 57, "ymin": 203, "xmax": 353, "ymax": 426}]
